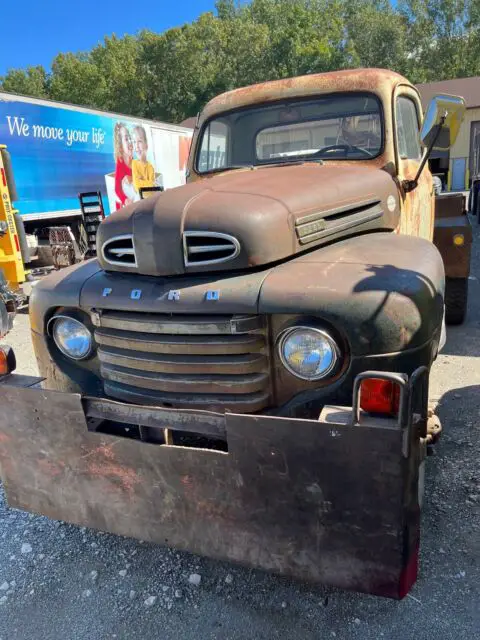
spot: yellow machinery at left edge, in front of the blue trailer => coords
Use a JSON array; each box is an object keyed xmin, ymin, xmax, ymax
[{"xmin": 0, "ymin": 145, "xmax": 27, "ymax": 293}]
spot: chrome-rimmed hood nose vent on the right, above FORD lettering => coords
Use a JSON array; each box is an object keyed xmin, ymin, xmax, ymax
[{"xmin": 183, "ymin": 231, "xmax": 240, "ymax": 267}]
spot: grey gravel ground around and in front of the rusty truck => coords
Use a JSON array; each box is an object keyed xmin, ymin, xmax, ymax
[{"xmin": 0, "ymin": 222, "xmax": 480, "ymax": 640}]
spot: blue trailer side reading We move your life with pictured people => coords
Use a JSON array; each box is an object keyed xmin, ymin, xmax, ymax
[{"xmin": 0, "ymin": 93, "xmax": 192, "ymax": 223}]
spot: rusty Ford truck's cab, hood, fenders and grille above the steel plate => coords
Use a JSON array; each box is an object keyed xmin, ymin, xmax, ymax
[{"xmin": 26, "ymin": 70, "xmax": 462, "ymax": 415}]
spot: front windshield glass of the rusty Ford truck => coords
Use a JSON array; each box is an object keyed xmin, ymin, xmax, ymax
[{"xmin": 197, "ymin": 93, "xmax": 383, "ymax": 173}]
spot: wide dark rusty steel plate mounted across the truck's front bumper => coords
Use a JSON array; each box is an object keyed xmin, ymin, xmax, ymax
[{"xmin": 0, "ymin": 374, "xmax": 420, "ymax": 598}]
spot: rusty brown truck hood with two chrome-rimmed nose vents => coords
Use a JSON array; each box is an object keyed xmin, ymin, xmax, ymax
[{"xmin": 97, "ymin": 163, "xmax": 400, "ymax": 276}]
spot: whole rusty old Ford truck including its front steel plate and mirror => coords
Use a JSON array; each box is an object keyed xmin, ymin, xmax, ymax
[{"xmin": 0, "ymin": 69, "xmax": 468, "ymax": 598}]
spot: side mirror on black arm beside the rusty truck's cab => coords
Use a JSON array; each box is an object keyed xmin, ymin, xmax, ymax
[{"xmin": 420, "ymin": 95, "xmax": 465, "ymax": 153}]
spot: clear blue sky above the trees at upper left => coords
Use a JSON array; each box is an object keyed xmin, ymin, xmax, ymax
[{"xmin": 0, "ymin": 0, "xmax": 215, "ymax": 75}]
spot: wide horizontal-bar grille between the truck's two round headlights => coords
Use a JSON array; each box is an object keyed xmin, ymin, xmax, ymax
[{"xmin": 92, "ymin": 310, "xmax": 271, "ymax": 413}]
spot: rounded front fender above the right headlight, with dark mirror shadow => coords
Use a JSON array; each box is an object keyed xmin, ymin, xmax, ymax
[{"xmin": 259, "ymin": 233, "xmax": 445, "ymax": 356}]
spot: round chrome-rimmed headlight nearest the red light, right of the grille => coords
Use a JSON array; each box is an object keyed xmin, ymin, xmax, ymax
[{"xmin": 279, "ymin": 327, "xmax": 339, "ymax": 380}]
